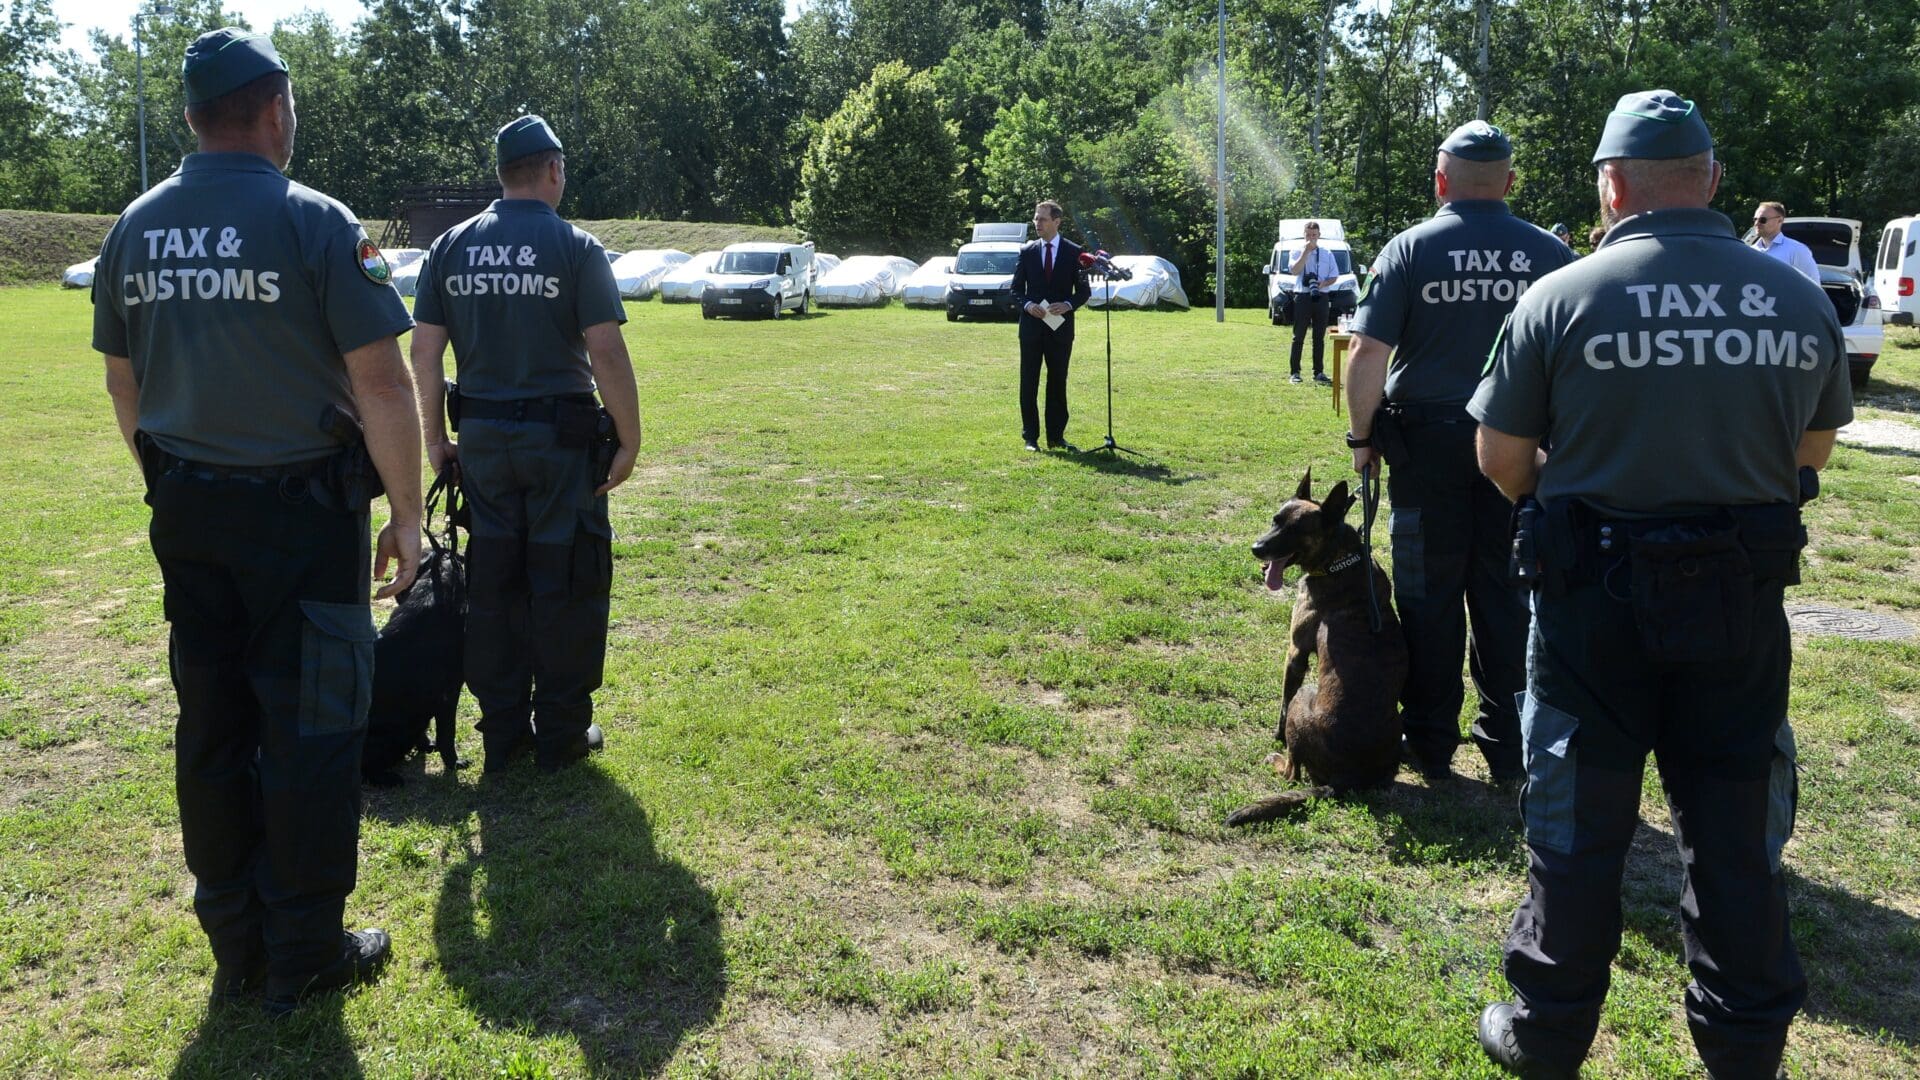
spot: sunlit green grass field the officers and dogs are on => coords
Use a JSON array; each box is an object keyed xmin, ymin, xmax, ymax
[{"xmin": 0, "ymin": 288, "xmax": 1920, "ymax": 1078}]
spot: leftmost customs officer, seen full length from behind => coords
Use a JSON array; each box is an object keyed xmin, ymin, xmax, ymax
[{"xmin": 94, "ymin": 29, "xmax": 420, "ymax": 1015}]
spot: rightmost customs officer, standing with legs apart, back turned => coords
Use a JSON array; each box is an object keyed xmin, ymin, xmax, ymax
[{"xmin": 1471, "ymin": 90, "xmax": 1853, "ymax": 1078}]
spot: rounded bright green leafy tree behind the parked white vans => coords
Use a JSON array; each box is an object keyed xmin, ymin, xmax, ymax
[{"xmin": 793, "ymin": 61, "xmax": 966, "ymax": 259}]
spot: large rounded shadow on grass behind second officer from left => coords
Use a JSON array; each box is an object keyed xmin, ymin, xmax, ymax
[{"xmin": 434, "ymin": 763, "xmax": 726, "ymax": 1076}]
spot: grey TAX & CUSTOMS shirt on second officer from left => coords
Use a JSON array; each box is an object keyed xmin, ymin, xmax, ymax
[{"xmin": 413, "ymin": 198, "xmax": 626, "ymax": 402}]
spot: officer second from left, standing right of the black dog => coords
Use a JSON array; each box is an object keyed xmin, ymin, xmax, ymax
[{"xmin": 413, "ymin": 115, "xmax": 639, "ymax": 773}]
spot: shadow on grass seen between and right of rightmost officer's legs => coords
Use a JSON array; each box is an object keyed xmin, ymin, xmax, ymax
[{"xmin": 1620, "ymin": 821, "xmax": 1920, "ymax": 1045}]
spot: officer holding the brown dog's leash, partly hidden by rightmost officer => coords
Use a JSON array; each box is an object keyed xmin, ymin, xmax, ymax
[{"xmin": 1346, "ymin": 119, "xmax": 1574, "ymax": 782}]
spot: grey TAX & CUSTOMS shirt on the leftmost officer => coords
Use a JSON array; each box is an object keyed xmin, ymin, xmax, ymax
[{"xmin": 94, "ymin": 154, "xmax": 413, "ymax": 467}]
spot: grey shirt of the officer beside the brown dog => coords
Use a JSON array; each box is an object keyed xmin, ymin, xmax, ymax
[{"xmin": 1354, "ymin": 200, "xmax": 1574, "ymax": 407}]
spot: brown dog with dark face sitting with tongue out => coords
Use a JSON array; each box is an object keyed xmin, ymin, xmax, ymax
[{"xmin": 1227, "ymin": 469, "xmax": 1407, "ymax": 824}]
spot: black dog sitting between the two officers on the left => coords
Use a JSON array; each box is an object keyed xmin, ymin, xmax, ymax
[{"xmin": 361, "ymin": 467, "xmax": 467, "ymax": 788}]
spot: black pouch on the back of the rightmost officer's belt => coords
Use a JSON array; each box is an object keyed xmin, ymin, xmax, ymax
[{"xmin": 1628, "ymin": 515, "xmax": 1755, "ymax": 663}]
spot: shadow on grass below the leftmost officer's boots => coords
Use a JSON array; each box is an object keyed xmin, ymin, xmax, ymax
[{"xmin": 173, "ymin": 994, "xmax": 363, "ymax": 1080}]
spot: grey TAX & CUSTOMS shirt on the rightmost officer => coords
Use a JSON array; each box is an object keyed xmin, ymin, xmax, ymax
[{"xmin": 1469, "ymin": 209, "xmax": 1853, "ymax": 517}]
